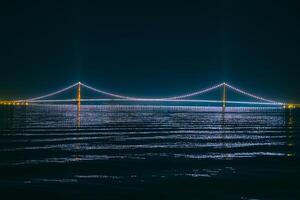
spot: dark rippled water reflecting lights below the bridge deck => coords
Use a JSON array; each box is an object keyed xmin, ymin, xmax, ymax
[{"xmin": 0, "ymin": 106, "xmax": 300, "ymax": 199}]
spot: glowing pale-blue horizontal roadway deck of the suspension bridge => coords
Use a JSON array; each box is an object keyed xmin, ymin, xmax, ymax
[{"xmin": 28, "ymin": 99, "xmax": 284, "ymax": 106}]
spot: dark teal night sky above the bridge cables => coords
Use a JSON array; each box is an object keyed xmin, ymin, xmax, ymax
[{"xmin": 0, "ymin": 0, "xmax": 300, "ymax": 102}]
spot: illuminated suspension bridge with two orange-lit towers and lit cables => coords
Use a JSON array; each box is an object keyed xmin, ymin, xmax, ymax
[{"xmin": 0, "ymin": 82, "xmax": 300, "ymax": 109}]
